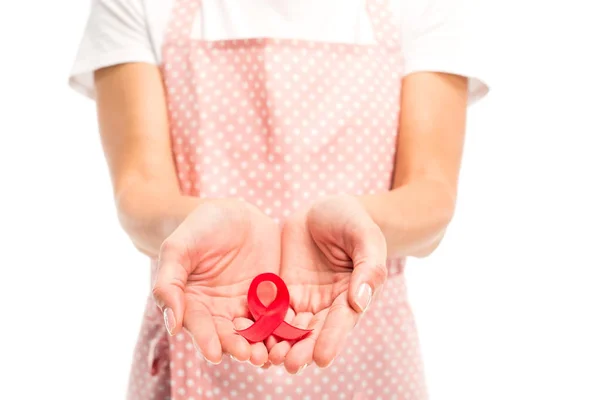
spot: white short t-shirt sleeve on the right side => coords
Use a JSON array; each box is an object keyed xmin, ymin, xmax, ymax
[{"xmin": 399, "ymin": 0, "xmax": 489, "ymax": 104}]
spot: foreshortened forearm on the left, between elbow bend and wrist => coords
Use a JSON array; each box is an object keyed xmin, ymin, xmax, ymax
[{"xmin": 115, "ymin": 177, "xmax": 200, "ymax": 257}]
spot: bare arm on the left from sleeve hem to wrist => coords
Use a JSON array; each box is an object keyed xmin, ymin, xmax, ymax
[{"xmin": 95, "ymin": 63, "xmax": 199, "ymax": 257}]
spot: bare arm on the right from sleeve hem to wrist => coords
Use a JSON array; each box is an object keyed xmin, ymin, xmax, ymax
[{"xmin": 361, "ymin": 72, "xmax": 467, "ymax": 257}]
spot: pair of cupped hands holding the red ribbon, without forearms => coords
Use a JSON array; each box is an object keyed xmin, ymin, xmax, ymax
[{"xmin": 153, "ymin": 195, "xmax": 387, "ymax": 374}]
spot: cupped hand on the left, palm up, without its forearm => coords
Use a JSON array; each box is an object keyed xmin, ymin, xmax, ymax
[{"xmin": 153, "ymin": 200, "xmax": 281, "ymax": 365}]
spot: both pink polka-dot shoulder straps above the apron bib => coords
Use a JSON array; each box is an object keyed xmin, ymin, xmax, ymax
[{"xmin": 166, "ymin": 0, "xmax": 400, "ymax": 48}]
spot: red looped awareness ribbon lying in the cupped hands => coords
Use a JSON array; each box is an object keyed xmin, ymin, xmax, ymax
[{"xmin": 237, "ymin": 272, "xmax": 312, "ymax": 343}]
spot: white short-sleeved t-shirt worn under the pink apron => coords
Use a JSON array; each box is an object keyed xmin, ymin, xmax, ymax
[{"xmin": 70, "ymin": 0, "xmax": 488, "ymax": 103}]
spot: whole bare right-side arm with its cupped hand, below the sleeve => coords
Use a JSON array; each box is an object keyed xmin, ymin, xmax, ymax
[{"xmin": 267, "ymin": 73, "xmax": 467, "ymax": 373}]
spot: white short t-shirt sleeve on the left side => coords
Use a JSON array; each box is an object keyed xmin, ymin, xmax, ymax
[{"xmin": 69, "ymin": 0, "xmax": 158, "ymax": 99}]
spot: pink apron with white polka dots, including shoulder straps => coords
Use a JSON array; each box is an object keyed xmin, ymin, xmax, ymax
[{"xmin": 128, "ymin": 0, "xmax": 427, "ymax": 400}]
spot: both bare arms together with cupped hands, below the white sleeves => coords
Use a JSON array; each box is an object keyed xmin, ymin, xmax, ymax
[{"xmin": 96, "ymin": 64, "xmax": 467, "ymax": 373}]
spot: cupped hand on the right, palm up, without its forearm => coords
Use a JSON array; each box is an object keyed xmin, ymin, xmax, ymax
[{"xmin": 269, "ymin": 196, "xmax": 387, "ymax": 373}]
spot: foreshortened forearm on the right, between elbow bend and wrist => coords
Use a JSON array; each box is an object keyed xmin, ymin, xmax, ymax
[{"xmin": 360, "ymin": 180, "xmax": 455, "ymax": 257}]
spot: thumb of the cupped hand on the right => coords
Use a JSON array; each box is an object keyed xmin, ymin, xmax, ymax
[{"xmin": 348, "ymin": 223, "xmax": 387, "ymax": 313}]
